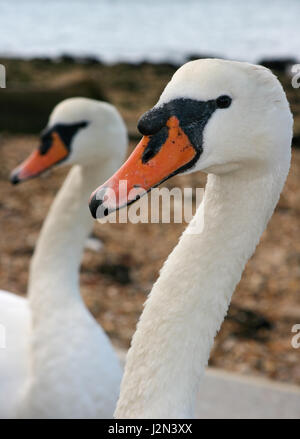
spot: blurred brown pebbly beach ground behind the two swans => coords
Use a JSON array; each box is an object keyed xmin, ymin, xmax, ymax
[{"xmin": 0, "ymin": 58, "xmax": 300, "ymax": 384}]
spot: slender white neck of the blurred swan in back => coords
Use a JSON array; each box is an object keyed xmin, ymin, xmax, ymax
[{"xmin": 28, "ymin": 162, "xmax": 117, "ymax": 324}]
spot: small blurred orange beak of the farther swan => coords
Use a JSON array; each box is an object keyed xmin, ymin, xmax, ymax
[{"xmin": 10, "ymin": 131, "xmax": 69, "ymax": 184}]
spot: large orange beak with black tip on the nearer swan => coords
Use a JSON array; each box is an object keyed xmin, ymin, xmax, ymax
[{"xmin": 90, "ymin": 116, "xmax": 197, "ymax": 218}]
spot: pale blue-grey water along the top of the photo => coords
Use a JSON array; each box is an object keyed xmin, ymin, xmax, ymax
[{"xmin": 0, "ymin": 0, "xmax": 300, "ymax": 63}]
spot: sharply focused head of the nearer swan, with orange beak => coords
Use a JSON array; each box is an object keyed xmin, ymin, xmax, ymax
[{"xmin": 90, "ymin": 59, "xmax": 293, "ymax": 217}]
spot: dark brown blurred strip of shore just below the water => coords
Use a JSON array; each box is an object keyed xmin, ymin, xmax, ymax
[{"xmin": 0, "ymin": 54, "xmax": 300, "ymax": 147}]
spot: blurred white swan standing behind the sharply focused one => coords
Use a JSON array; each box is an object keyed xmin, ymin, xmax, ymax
[{"xmin": 0, "ymin": 98, "xmax": 127, "ymax": 418}]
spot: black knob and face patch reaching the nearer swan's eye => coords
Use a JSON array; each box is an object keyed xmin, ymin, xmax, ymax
[{"xmin": 138, "ymin": 98, "xmax": 217, "ymax": 175}]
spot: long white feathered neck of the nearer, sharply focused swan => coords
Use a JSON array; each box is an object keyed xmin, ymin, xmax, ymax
[{"xmin": 115, "ymin": 164, "xmax": 288, "ymax": 418}]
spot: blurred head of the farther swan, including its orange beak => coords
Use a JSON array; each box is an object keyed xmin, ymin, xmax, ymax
[{"xmin": 10, "ymin": 98, "xmax": 127, "ymax": 184}]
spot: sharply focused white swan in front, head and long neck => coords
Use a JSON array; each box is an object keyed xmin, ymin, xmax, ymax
[{"xmin": 90, "ymin": 59, "xmax": 293, "ymax": 418}]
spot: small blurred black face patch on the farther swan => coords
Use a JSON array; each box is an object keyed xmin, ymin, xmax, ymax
[{"xmin": 39, "ymin": 121, "xmax": 88, "ymax": 155}]
